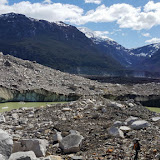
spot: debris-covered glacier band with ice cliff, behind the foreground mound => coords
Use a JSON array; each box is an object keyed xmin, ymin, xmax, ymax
[{"xmin": 0, "ymin": 53, "xmax": 160, "ymax": 106}]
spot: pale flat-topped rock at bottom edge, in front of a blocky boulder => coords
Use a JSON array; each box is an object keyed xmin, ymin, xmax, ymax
[{"xmin": 9, "ymin": 151, "xmax": 38, "ymax": 160}]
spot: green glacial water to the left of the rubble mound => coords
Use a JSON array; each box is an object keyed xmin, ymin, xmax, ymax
[{"xmin": 0, "ymin": 102, "xmax": 64, "ymax": 112}]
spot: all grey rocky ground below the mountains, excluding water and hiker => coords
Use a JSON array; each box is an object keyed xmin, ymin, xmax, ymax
[{"xmin": 0, "ymin": 53, "xmax": 160, "ymax": 160}]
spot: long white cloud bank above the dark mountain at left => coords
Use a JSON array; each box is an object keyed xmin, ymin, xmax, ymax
[{"xmin": 0, "ymin": 1, "xmax": 83, "ymax": 22}]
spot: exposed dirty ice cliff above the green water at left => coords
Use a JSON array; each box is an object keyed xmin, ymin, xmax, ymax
[{"xmin": 0, "ymin": 87, "xmax": 80, "ymax": 102}]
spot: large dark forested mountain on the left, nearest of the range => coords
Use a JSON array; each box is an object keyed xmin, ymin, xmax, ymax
[{"xmin": 0, "ymin": 13, "xmax": 123, "ymax": 74}]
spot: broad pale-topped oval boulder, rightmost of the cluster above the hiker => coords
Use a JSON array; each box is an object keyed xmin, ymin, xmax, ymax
[{"xmin": 130, "ymin": 120, "xmax": 150, "ymax": 130}]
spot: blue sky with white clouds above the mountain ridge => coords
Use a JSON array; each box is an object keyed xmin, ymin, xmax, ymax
[{"xmin": 0, "ymin": 0, "xmax": 160, "ymax": 48}]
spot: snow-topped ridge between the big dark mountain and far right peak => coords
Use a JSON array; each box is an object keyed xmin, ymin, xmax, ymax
[{"xmin": 78, "ymin": 27, "xmax": 135, "ymax": 68}]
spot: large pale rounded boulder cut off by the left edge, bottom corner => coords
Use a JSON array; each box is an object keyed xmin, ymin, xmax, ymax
[{"xmin": 0, "ymin": 129, "xmax": 13, "ymax": 159}]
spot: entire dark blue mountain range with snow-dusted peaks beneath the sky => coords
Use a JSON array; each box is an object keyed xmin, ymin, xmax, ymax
[{"xmin": 0, "ymin": 13, "xmax": 160, "ymax": 75}]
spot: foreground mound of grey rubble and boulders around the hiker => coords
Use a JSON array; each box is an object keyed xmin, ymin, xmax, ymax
[{"xmin": 0, "ymin": 96, "xmax": 160, "ymax": 160}]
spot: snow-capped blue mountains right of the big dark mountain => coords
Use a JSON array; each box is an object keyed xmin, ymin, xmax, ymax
[{"xmin": 78, "ymin": 27, "xmax": 160, "ymax": 74}]
